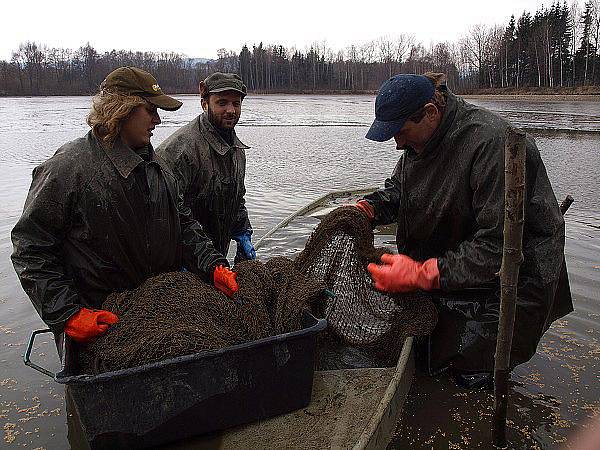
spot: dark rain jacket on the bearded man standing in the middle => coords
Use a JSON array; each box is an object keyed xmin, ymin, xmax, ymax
[{"xmin": 156, "ymin": 113, "xmax": 252, "ymax": 255}]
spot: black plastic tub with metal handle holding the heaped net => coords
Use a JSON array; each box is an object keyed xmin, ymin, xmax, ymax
[{"xmin": 26, "ymin": 313, "xmax": 326, "ymax": 449}]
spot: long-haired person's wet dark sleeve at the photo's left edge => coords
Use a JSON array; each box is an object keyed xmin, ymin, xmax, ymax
[{"xmin": 11, "ymin": 166, "xmax": 79, "ymax": 332}]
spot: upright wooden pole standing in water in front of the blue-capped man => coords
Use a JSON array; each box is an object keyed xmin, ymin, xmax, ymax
[{"xmin": 493, "ymin": 127, "xmax": 525, "ymax": 448}]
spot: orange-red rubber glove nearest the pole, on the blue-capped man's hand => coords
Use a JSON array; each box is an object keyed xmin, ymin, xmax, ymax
[{"xmin": 367, "ymin": 253, "xmax": 440, "ymax": 293}]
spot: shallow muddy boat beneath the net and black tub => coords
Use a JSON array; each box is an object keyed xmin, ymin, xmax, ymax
[{"xmin": 186, "ymin": 188, "xmax": 415, "ymax": 450}]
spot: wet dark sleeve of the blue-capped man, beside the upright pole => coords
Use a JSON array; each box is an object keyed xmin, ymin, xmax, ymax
[{"xmin": 438, "ymin": 137, "xmax": 504, "ymax": 291}]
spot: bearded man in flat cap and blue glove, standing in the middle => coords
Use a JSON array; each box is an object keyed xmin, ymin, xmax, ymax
[{"xmin": 157, "ymin": 72, "xmax": 256, "ymax": 262}]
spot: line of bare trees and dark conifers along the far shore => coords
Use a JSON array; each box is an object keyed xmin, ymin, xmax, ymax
[{"xmin": 0, "ymin": 0, "xmax": 600, "ymax": 95}]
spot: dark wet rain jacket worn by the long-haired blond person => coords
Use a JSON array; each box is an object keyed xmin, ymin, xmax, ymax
[{"xmin": 12, "ymin": 131, "xmax": 227, "ymax": 332}]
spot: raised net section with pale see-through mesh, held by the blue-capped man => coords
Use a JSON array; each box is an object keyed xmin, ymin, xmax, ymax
[{"xmin": 296, "ymin": 207, "xmax": 437, "ymax": 363}]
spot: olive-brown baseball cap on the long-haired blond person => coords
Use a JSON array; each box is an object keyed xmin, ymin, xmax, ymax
[{"xmin": 100, "ymin": 66, "xmax": 183, "ymax": 111}]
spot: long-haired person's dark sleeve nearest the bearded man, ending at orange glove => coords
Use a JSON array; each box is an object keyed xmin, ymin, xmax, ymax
[{"xmin": 177, "ymin": 187, "xmax": 229, "ymax": 282}]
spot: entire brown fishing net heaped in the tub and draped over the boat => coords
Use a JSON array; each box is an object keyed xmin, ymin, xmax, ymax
[{"xmin": 80, "ymin": 207, "xmax": 437, "ymax": 374}]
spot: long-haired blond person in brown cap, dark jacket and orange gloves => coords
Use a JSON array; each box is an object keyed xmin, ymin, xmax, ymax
[{"xmin": 12, "ymin": 67, "xmax": 237, "ymax": 342}]
